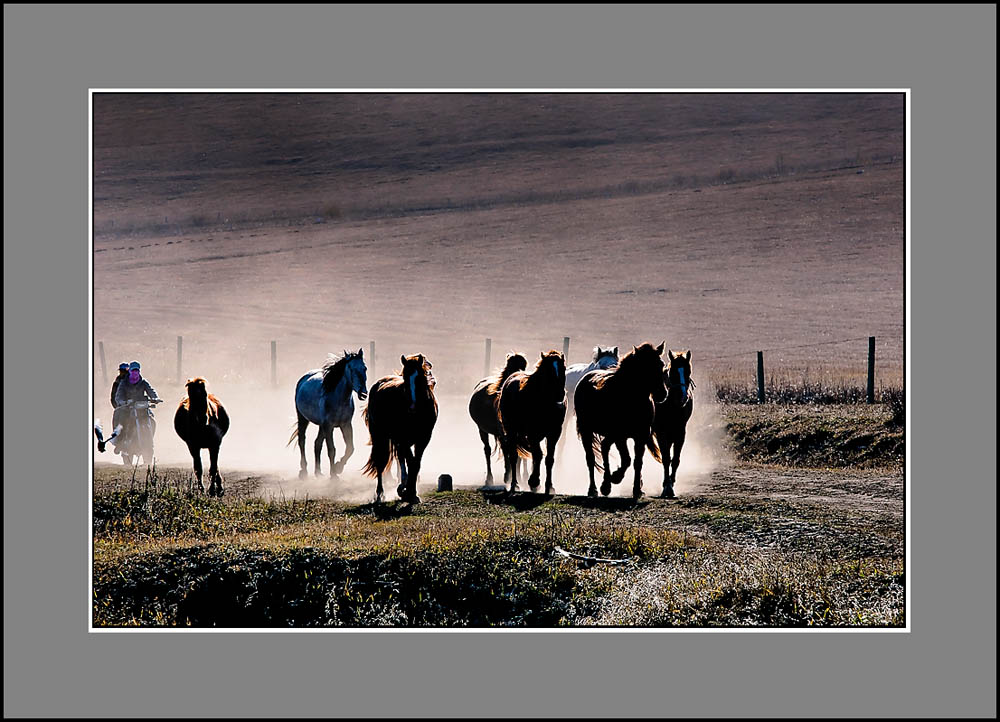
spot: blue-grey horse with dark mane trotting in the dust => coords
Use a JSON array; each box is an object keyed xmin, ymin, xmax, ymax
[{"xmin": 288, "ymin": 349, "xmax": 368, "ymax": 479}]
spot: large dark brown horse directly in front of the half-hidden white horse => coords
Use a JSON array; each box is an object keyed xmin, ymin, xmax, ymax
[{"xmin": 574, "ymin": 343, "xmax": 667, "ymax": 499}]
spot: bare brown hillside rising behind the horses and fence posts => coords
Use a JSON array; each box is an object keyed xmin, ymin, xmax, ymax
[{"xmin": 93, "ymin": 93, "xmax": 905, "ymax": 478}]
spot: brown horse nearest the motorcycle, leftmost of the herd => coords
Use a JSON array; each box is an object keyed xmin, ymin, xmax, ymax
[{"xmin": 174, "ymin": 376, "xmax": 229, "ymax": 496}]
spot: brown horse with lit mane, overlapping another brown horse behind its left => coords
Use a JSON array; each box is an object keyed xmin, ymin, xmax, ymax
[{"xmin": 497, "ymin": 351, "xmax": 566, "ymax": 494}]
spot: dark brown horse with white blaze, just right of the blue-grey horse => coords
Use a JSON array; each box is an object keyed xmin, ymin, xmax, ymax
[{"xmin": 363, "ymin": 354, "xmax": 437, "ymax": 504}]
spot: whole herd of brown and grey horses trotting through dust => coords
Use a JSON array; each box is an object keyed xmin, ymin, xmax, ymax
[{"xmin": 98, "ymin": 343, "xmax": 694, "ymax": 503}]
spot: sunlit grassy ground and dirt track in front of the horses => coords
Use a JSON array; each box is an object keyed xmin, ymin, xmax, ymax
[{"xmin": 93, "ymin": 448, "xmax": 905, "ymax": 627}]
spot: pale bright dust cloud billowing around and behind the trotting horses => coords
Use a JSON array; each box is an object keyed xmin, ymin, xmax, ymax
[{"xmin": 94, "ymin": 334, "xmax": 722, "ymax": 502}]
